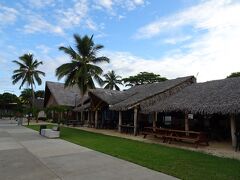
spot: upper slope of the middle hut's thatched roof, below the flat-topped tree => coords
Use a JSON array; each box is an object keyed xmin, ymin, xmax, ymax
[{"xmin": 110, "ymin": 76, "xmax": 195, "ymax": 111}]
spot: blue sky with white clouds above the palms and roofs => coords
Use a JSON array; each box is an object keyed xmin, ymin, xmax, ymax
[{"xmin": 0, "ymin": 0, "xmax": 240, "ymax": 94}]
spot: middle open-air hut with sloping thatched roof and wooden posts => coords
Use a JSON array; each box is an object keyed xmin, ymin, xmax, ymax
[{"xmin": 110, "ymin": 76, "xmax": 196, "ymax": 135}]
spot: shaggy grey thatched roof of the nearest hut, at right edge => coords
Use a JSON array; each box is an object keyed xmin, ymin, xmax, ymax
[{"xmin": 142, "ymin": 78, "xmax": 240, "ymax": 114}]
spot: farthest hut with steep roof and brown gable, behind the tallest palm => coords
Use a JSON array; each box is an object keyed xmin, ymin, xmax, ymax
[{"xmin": 44, "ymin": 81, "xmax": 80, "ymax": 119}]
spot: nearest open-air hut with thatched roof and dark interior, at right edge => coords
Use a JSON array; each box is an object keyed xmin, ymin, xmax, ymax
[{"xmin": 140, "ymin": 78, "xmax": 240, "ymax": 146}]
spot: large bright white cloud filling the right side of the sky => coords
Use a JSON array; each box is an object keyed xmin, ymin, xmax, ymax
[{"xmin": 127, "ymin": 0, "xmax": 240, "ymax": 81}]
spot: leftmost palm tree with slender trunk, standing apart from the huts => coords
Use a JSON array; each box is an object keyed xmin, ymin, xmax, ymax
[{"xmin": 12, "ymin": 54, "xmax": 45, "ymax": 124}]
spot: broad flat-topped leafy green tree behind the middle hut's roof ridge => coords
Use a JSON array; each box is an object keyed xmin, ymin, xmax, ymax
[{"xmin": 122, "ymin": 72, "xmax": 167, "ymax": 86}]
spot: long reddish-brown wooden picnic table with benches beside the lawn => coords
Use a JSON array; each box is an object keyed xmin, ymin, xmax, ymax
[{"xmin": 142, "ymin": 127, "xmax": 208, "ymax": 148}]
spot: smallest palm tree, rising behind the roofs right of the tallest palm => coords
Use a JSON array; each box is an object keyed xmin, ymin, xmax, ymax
[{"xmin": 103, "ymin": 70, "xmax": 122, "ymax": 91}]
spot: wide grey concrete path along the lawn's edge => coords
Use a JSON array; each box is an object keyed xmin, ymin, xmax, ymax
[{"xmin": 0, "ymin": 120, "xmax": 175, "ymax": 180}]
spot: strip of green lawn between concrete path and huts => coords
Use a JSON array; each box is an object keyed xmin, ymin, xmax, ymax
[{"xmin": 26, "ymin": 125, "xmax": 240, "ymax": 180}]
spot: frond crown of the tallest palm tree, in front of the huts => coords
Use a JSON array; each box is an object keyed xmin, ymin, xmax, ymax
[{"xmin": 56, "ymin": 34, "xmax": 109, "ymax": 97}]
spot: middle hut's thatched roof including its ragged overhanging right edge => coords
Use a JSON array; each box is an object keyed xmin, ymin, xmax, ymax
[{"xmin": 110, "ymin": 76, "xmax": 196, "ymax": 111}]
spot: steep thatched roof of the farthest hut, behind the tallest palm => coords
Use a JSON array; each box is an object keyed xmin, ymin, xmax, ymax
[{"xmin": 44, "ymin": 81, "xmax": 80, "ymax": 107}]
